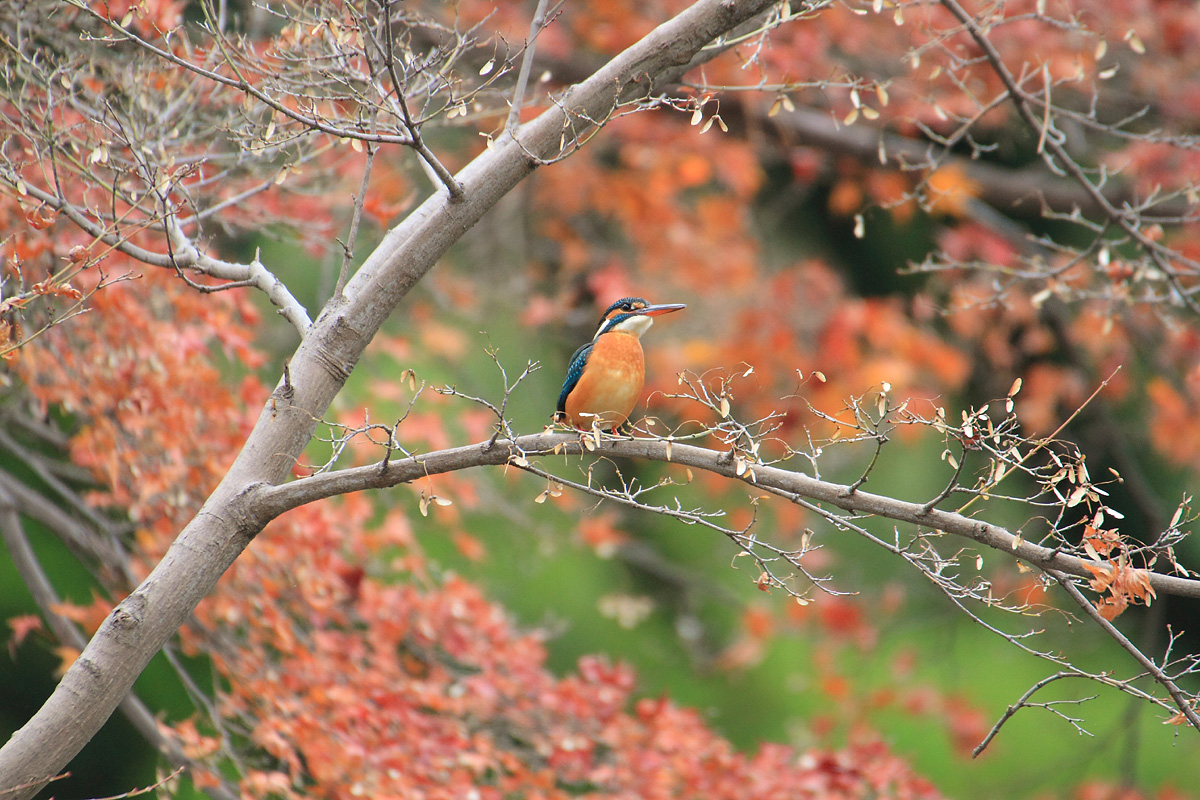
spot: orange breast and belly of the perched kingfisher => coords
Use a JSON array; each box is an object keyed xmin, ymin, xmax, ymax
[{"xmin": 566, "ymin": 331, "xmax": 646, "ymax": 431}]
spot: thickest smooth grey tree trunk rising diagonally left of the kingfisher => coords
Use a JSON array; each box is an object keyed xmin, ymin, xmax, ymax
[{"xmin": 0, "ymin": 0, "xmax": 773, "ymax": 800}]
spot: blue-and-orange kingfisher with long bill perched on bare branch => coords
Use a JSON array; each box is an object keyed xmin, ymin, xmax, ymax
[{"xmin": 554, "ymin": 297, "xmax": 685, "ymax": 433}]
